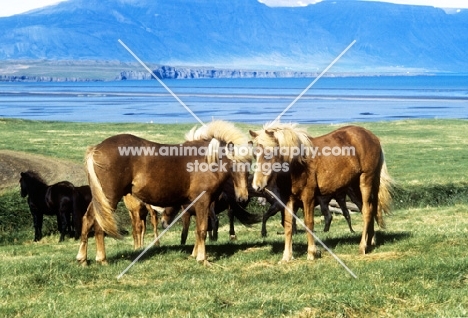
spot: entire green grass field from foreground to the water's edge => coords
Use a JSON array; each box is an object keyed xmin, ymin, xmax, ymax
[{"xmin": 0, "ymin": 120, "xmax": 468, "ymax": 317}]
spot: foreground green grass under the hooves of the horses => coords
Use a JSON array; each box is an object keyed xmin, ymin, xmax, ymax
[{"xmin": 0, "ymin": 205, "xmax": 468, "ymax": 317}]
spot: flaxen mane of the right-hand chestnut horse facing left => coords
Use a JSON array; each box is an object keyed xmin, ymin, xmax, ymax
[{"xmin": 254, "ymin": 122, "xmax": 313, "ymax": 162}]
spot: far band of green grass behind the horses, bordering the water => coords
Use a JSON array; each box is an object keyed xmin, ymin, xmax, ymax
[{"xmin": 0, "ymin": 119, "xmax": 468, "ymax": 208}]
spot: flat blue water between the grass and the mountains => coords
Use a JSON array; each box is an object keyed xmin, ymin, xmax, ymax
[{"xmin": 0, "ymin": 75, "xmax": 468, "ymax": 124}]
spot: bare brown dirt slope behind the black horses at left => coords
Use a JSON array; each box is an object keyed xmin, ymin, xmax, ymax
[{"xmin": 0, "ymin": 150, "xmax": 87, "ymax": 192}]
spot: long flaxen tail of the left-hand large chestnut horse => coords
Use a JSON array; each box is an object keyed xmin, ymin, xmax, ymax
[{"xmin": 85, "ymin": 147, "xmax": 121, "ymax": 238}]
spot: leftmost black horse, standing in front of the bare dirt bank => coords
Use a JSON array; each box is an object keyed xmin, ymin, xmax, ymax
[{"xmin": 19, "ymin": 170, "xmax": 77, "ymax": 242}]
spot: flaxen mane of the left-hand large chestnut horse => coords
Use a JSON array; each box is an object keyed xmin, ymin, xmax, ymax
[{"xmin": 185, "ymin": 120, "xmax": 252, "ymax": 162}]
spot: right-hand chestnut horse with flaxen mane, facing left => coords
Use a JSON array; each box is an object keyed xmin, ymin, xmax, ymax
[{"xmin": 250, "ymin": 122, "xmax": 391, "ymax": 261}]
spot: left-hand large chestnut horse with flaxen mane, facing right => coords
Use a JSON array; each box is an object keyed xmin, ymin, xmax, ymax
[{"xmin": 77, "ymin": 121, "xmax": 252, "ymax": 263}]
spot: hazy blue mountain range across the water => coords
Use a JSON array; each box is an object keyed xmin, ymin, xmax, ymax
[{"xmin": 0, "ymin": 0, "xmax": 468, "ymax": 73}]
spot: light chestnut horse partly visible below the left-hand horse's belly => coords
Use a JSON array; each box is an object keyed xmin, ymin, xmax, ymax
[{"xmin": 123, "ymin": 194, "xmax": 159, "ymax": 250}]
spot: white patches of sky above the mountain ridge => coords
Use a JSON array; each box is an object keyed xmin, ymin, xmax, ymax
[{"xmin": 0, "ymin": 0, "xmax": 468, "ymax": 17}]
